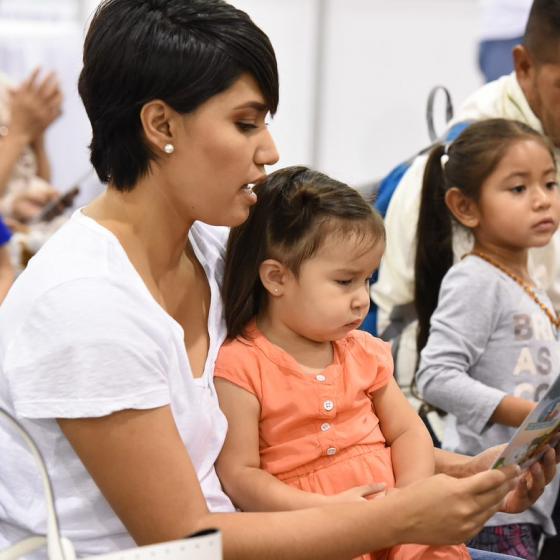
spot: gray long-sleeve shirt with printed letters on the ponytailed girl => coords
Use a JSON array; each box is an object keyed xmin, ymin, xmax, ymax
[{"xmin": 417, "ymin": 256, "xmax": 560, "ymax": 534}]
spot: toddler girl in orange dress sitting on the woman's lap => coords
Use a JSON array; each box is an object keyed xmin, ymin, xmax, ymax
[{"xmin": 215, "ymin": 167, "xmax": 470, "ymax": 560}]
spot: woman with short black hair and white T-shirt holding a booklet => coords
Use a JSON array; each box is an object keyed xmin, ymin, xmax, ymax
[{"xmin": 0, "ymin": 0, "xmax": 554, "ymax": 560}]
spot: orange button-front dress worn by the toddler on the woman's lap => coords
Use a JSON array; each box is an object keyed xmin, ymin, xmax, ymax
[{"xmin": 214, "ymin": 324, "xmax": 470, "ymax": 560}]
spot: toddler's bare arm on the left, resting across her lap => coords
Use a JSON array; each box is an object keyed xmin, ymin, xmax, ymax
[{"xmin": 215, "ymin": 378, "xmax": 383, "ymax": 511}]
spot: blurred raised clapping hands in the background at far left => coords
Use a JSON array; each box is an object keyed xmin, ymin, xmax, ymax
[{"xmin": 9, "ymin": 68, "xmax": 62, "ymax": 144}]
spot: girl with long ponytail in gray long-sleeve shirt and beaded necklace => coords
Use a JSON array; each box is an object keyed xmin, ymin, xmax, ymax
[{"xmin": 415, "ymin": 119, "xmax": 560, "ymax": 560}]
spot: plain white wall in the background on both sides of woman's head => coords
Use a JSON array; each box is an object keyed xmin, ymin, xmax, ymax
[{"xmin": 0, "ymin": 0, "xmax": 481, "ymax": 197}]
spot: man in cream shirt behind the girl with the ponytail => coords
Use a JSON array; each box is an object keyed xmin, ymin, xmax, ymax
[{"xmin": 371, "ymin": 0, "xmax": 560, "ymax": 558}]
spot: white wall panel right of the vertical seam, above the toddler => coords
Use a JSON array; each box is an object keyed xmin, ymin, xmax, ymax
[{"xmin": 317, "ymin": 0, "xmax": 481, "ymax": 188}]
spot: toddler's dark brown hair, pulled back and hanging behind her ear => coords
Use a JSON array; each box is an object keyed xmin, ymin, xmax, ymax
[{"xmin": 223, "ymin": 167, "xmax": 385, "ymax": 338}]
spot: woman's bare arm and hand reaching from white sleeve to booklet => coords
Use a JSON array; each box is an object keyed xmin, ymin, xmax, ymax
[{"xmin": 58, "ymin": 406, "xmax": 517, "ymax": 560}]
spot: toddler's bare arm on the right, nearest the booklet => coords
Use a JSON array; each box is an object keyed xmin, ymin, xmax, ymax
[{"xmin": 371, "ymin": 378, "xmax": 435, "ymax": 487}]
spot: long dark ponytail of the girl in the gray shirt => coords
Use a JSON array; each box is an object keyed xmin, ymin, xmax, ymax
[{"xmin": 414, "ymin": 144, "xmax": 453, "ymax": 354}]
